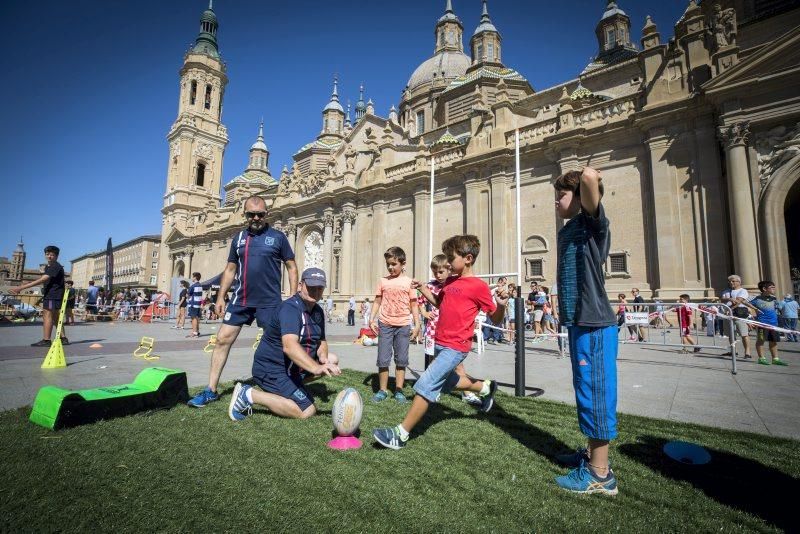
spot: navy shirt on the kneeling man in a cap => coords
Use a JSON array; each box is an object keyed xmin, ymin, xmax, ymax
[{"xmin": 253, "ymin": 294, "xmax": 325, "ymax": 379}]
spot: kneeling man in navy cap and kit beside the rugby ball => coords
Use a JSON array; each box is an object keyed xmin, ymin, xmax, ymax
[{"xmin": 228, "ymin": 268, "xmax": 341, "ymax": 421}]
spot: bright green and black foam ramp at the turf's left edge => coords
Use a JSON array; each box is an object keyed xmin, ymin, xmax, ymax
[{"xmin": 30, "ymin": 367, "xmax": 189, "ymax": 430}]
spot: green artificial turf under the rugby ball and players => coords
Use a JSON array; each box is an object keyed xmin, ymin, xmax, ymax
[{"xmin": 0, "ymin": 371, "xmax": 800, "ymax": 532}]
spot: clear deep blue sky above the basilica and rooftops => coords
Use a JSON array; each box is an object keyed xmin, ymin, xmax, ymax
[{"xmin": 0, "ymin": 0, "xmax": 686, "ymax": 269}]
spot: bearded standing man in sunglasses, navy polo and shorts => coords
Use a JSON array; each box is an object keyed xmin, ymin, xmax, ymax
[{"xmin": 189, "ymin": 195, "xmax": 297, "ymax": 408}]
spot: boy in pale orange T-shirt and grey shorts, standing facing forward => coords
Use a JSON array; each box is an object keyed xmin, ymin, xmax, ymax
[{"xmin": 369, "ymin": 247, "xmax": 419, "ymax": 402}]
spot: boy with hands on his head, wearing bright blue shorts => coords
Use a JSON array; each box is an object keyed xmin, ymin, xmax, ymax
[{"xmin": 554, "ymin": 167, "xmax": 617, "ymax": 495}]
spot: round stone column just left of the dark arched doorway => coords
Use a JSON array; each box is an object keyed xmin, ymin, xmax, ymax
[{"xmin": 720, "ymin": 122, "xmax": 759, "ymax": 288}]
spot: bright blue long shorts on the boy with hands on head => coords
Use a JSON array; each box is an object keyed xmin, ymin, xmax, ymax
[{"xmin": 568, "ymin": 325, "xmax": 617, "ymax": 440}]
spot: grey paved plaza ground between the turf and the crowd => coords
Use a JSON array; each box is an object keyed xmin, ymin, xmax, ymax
[{"xmin": 0, "ymin": 322, "xmax": 800, "ymax": 439}]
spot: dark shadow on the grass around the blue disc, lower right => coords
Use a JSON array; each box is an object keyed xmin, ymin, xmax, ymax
[{"xmin": 618, "ymin": 436, "xmax": 800, "ymax": 531}]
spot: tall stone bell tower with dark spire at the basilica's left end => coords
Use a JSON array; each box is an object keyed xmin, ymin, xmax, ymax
[{"xmin": 161, "ymin": 0, "xmax": 228, "ymax": 239}]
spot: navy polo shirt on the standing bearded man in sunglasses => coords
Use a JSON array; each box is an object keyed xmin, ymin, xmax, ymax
[{"xmin": 228, "ymin": 226, "xmax": 294, "ymax": 308}]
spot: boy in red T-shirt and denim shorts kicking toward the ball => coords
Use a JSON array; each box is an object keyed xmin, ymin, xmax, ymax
[{"xmin": 372, "ymin": 235, "xmax": 508, "ymax": 450}]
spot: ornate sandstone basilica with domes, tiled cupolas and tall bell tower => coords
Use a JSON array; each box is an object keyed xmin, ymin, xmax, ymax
[{"xmin": 158, "ymin": 0, "xmax": 800, "ymax": 301}]
